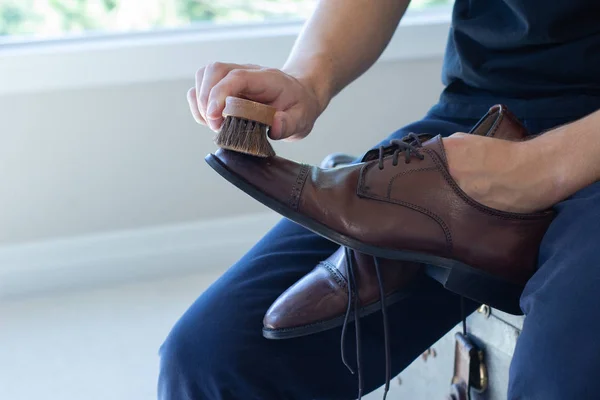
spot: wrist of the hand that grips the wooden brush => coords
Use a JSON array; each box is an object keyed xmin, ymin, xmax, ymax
[{"xmin": 282, "ymin": 56, "xmax": 336, "ymax": 115}]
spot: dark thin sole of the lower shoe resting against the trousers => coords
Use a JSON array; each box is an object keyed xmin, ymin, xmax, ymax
[{"xmin": 263, "ymin": 291, "xmax": 408, "ymax": 340}]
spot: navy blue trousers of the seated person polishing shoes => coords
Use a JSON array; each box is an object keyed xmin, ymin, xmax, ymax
[{"xmin": 158, "ymin": 104, "xmax": 600, "ymax": 400}]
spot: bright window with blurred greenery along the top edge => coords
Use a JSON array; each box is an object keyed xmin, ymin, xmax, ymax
[{"xmin": 0, "ymin": 0, "xmax": 452, "ymax": 42}]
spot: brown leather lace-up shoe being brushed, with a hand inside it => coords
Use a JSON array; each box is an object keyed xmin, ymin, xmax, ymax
[{"xmin": 206, "ymin": 106, "xmax": 554, "ymax": 314}]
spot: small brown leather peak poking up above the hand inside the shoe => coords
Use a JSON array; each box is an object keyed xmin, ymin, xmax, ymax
[{"xmin": 469, "ymin": 104, "xmax": 529, "ymax": 141}]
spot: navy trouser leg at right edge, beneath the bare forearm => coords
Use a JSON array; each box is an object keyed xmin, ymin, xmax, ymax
[{"xmin": 509, "ymin": 183, "xmax": 600, "ymax": 400}]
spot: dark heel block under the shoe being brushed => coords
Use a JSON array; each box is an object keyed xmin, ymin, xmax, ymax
[{"xmin": 425, "ymin": 265, "xmax": 523, "ymax": 315}]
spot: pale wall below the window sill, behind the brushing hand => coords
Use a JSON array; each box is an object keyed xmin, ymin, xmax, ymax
[{"xmin": 0, "ymin": 60, "xmax": 440, "ymax": 243}]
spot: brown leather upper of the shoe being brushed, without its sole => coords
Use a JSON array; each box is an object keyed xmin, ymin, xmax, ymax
[{"xmin": 210, "ymin": 106, "xmax": 554, "ymax": 284}]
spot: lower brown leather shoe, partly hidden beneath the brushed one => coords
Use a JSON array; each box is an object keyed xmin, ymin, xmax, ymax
[{"xmin": 263, "ymin": 247, "xmax": 422, "ymax": 339}]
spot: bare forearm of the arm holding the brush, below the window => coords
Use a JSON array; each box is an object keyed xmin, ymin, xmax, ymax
[{"xmin": 283, "ymin": 0, "xmax": 410, "ymax": 111}]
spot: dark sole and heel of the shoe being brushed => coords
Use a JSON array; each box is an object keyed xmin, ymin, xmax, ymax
[{"xmin": 205, "ymin": 154, "xmax": 524, "ymax": 315}]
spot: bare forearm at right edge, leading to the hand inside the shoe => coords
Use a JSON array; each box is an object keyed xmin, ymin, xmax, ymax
[{"xmin": 523, "ymin": 111, "xmax": 600, "ymax": 202}]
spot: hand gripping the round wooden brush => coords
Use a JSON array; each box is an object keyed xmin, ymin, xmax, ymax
[{"xmin": 187, "ymin": 63, "xmax": 323, "ymax": 140}]
